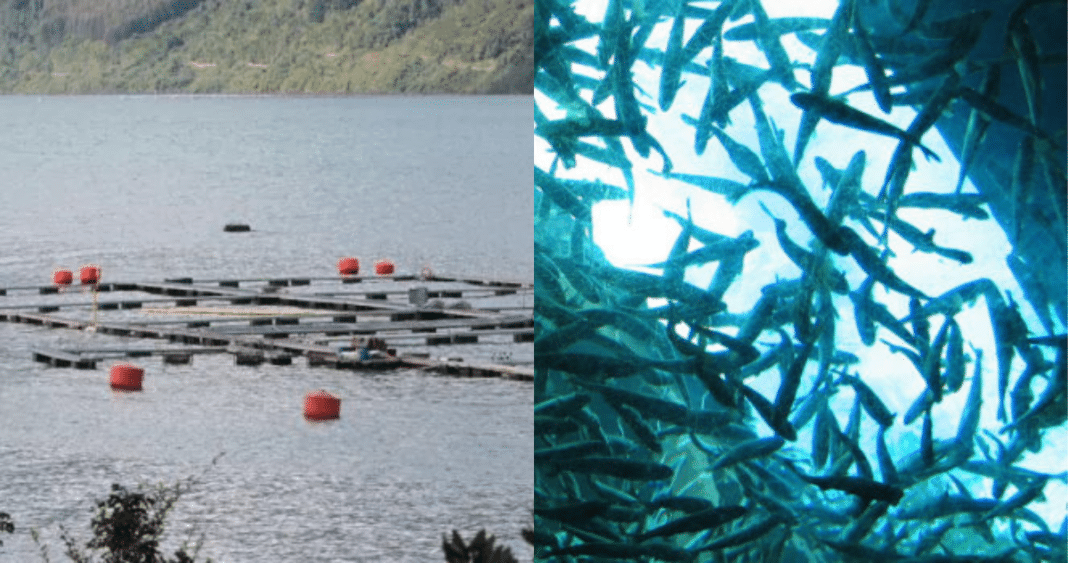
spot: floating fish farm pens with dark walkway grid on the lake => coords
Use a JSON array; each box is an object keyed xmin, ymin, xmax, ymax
[{"xmin": 0, "ymin": 271, "xmax": 534, "ymax": 380}]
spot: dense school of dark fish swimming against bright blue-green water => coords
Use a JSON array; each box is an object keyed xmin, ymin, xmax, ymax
[{"xmin": 538, "ymin": 0, "xmax": 1068, "ymax": 563}]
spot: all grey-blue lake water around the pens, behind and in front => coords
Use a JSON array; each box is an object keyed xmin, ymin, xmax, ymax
[{"xmin": 0, "ymin": 96, "xmax": 533, "ymax": 562}]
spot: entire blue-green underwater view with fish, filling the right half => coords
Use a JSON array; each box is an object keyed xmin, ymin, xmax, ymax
[{"xmin": 527, "ymin": 0, "xmax": 1068, "ymax": 563}]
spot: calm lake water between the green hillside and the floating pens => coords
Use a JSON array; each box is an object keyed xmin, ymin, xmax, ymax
[{"xmin": 0, "ymin": 96, "xmax": 533, "ymax": 283}]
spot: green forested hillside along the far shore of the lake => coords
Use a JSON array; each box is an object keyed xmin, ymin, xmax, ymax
[{"xmin": 0, "ymin": 0, "xmax": 534, "ymax": 94}]
